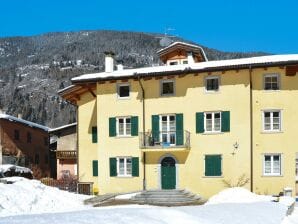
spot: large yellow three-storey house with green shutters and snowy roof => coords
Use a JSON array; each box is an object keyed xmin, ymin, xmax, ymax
[{"xmin": 60, "ymin": 40, "xmax": 298, "ymax": 197}]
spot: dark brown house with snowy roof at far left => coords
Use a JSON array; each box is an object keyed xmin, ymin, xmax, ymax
[{"xmin": 0, "ymin": 114, "xmax": 51, "ymax": 177}]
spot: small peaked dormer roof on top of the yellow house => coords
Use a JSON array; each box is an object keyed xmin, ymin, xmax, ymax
[{"xmin": 156, "ymin": 41, "xmax": 208, "ymax": 61}]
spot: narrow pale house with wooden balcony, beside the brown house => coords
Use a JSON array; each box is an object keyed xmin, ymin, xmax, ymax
[{"xmin": 49, "ymin": 123, "xmax": 77, "ymax": 180}]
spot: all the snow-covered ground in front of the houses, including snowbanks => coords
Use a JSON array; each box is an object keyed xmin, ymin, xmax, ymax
[{"xmin": 0, "ymin": 178, "xmax": 298, "ymax": 224}]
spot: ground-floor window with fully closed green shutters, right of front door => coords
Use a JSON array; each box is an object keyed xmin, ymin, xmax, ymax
[{"xmin": 205, "ymin": 155, "xmax": 222, "ymax": 177}]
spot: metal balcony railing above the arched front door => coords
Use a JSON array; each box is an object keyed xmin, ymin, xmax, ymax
[{"xmin": 139, "ymin": 131, "xmax": 190, "ymax": 148}]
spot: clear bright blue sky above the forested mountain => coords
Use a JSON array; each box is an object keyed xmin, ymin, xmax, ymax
[{"xmin": 0, "ymin": 0, "xmax": 298, "ymax": 54}]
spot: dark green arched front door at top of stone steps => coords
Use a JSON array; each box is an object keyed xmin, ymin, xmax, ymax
[{"xmin": 161, "ymin": 157, "xmax": 176, "ymax": 189}]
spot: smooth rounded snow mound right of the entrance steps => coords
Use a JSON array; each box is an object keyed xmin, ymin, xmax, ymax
[{"xmin": 206, "ymin": 187, "xmax": 272, "ymax": 205}]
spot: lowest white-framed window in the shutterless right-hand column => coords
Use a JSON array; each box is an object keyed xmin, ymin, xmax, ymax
[{"xmin": 264, "ymin": 154, "xmax": 281, "ymax": 176}]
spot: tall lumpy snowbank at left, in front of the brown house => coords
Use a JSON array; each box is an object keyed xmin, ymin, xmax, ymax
[{"xmin": 0, "ymin": 177, "xmax": 90, "ymax": 216}]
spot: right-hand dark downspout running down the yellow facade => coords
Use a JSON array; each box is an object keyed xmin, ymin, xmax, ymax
[{"xmin": 249, "ymin": 65, "xmax": 254, "ymax": 192}]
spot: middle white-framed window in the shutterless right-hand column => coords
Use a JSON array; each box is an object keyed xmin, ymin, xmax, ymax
[{"xmin": 263, "ymin": 110, "xmax": 281, "ymax": 131}]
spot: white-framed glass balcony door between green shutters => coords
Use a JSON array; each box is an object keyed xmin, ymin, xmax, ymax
[{"xmin": 160, "ymin": 115, "xmax": 176, "ymax": 145}]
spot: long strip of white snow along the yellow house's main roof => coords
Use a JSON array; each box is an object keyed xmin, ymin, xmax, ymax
[{"xmin": 71, "ymin": 54, "xmax": 298, "ymax": 82}]
